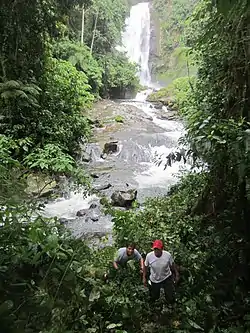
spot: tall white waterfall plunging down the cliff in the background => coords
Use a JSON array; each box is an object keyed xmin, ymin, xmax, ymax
[{"xmin": 122, "ymin": 2, "xmax": 151, "ymax": 86}]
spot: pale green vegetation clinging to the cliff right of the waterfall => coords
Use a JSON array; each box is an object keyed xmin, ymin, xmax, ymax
[{"xmin": 153, "ymin": 0, "xmax": 199, "ymax": 84}]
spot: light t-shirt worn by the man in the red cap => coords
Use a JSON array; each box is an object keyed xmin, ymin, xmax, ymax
[{"xmin": 145, "ymin": 251, "xmax": 174, "ymax": 283}]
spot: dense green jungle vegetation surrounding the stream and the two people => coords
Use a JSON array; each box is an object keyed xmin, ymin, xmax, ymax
[{"xmin": 0, "ymin": 0, "xmax": 250, "ymax": 333}]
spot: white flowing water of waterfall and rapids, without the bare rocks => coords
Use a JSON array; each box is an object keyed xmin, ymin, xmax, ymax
[{"xmin": 41, "ymin": 2, "xmax": 186, "ymax": 241}]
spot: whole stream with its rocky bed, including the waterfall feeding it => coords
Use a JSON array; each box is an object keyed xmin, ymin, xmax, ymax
[{"xmin": 43, "ymin": 2, "xmax": 186, "ymax": 243}]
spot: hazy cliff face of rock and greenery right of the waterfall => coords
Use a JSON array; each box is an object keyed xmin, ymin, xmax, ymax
[{"xmin": 149, "ymin": 0, "xmax": 199, "ymax": 85}]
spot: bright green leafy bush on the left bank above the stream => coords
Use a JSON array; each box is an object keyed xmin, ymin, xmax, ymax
[{"xmin": 39, "ymin": 59, "xmax": 94, "ymax": 152}]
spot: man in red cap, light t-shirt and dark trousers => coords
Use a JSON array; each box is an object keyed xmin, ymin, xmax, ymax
[{"xmin": 143, "ymin": 240, "xmax": 179, "ymax": 304}]
